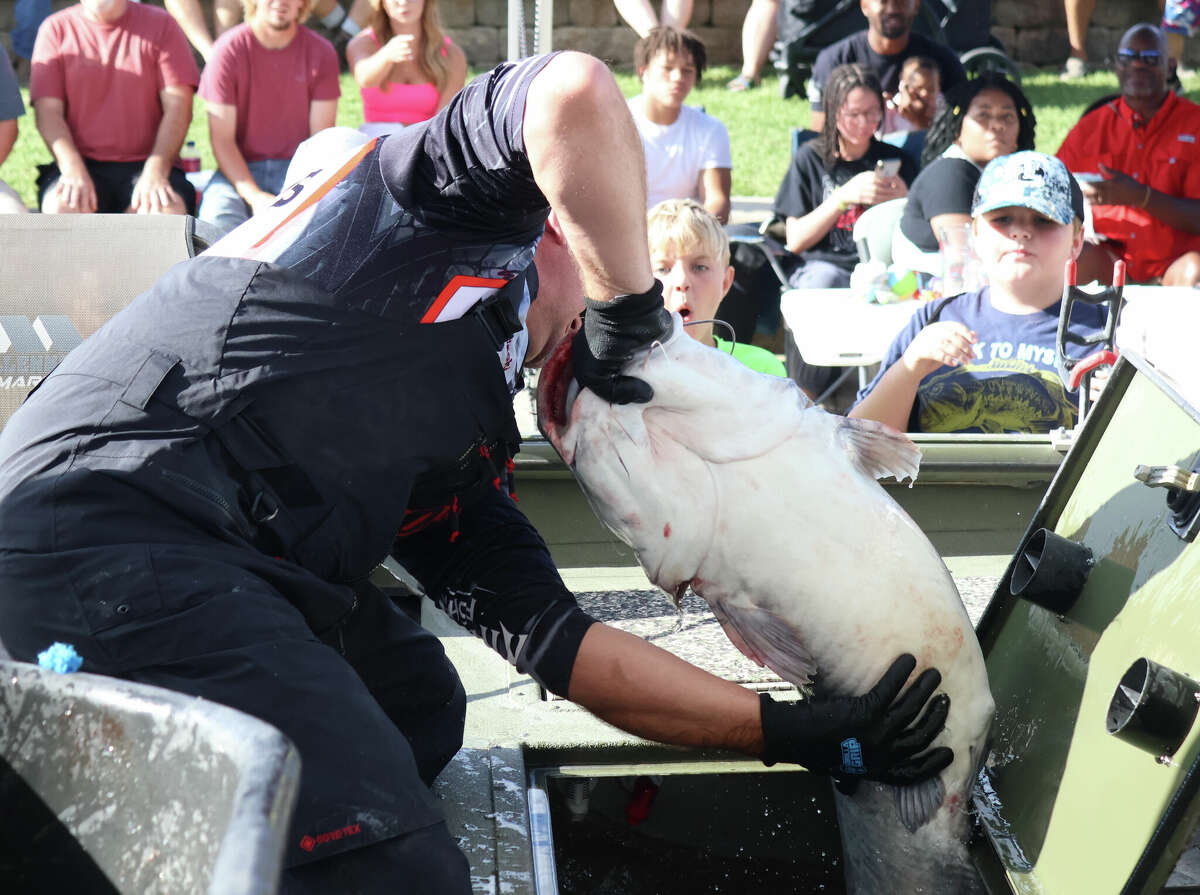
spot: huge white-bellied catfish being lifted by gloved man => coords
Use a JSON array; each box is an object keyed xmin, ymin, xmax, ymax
[{"xmin": 539, "ymin": 317, "xmax": 994, "ymax": 895}]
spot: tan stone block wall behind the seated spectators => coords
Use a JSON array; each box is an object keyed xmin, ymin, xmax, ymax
[{"xmin": 0, "ymin": 0, "xmax": 1185, "ymax": 67}]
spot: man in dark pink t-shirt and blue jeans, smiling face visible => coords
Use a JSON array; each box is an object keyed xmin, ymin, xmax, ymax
[{"xmin": 200, "ymin": 0, "xmax": 341, "ymax": 232}]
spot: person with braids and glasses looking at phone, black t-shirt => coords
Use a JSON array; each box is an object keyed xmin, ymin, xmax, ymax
[{"xmin": 775, "ymin": 64, "xmax": 917, "ymax": 395}]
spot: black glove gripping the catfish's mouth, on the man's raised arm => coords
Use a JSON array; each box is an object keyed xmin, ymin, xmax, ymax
[{"xmin": 571, "ymin": 280, "xmax": 671, "ymax": 404}]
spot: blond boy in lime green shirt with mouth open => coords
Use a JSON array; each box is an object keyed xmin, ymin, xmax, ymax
[{"xmin": 647, "ymin": 199, "xmax": 787, "ymax": 377}]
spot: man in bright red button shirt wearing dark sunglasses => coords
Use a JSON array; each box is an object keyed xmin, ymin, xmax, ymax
[{"xmin": 1058, "ymin": 23, "xmax": 1200, "ymax": 286}]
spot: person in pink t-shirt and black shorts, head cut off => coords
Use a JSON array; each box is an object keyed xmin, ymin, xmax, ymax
[{"xmin": 29, "ymin": 0, "xmax": 199, "ymax": 215}]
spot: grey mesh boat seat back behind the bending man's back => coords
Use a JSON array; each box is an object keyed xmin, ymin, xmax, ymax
[{"xmin": 0, "ymin": 215, "xmax": 215, "ymax": 426}]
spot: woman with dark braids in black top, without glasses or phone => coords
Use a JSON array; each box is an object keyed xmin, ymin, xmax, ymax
[{"xmin": 892, "ymin": 72, "xmax": 1037, "ymax": 274}]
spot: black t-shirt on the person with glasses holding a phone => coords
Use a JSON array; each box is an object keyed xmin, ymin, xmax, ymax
[{"xmin": 775, "ymin": 139, "xmax": 917, "ymax": 270}]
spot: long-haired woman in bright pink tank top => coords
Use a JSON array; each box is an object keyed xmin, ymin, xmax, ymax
[{"xmin": 346, "ymin": 0, "xmax": 467, "ymax": 137}]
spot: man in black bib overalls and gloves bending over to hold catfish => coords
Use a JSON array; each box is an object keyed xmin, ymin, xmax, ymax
[{"xmin": 0, "ymin": 53, "xmax": 950, "ymax": 894}]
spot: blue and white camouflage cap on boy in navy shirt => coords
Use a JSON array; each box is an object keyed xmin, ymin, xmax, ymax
[{"xmin": 971, "ymin": 151, "xmax": 1084, "ymax": 224}]
